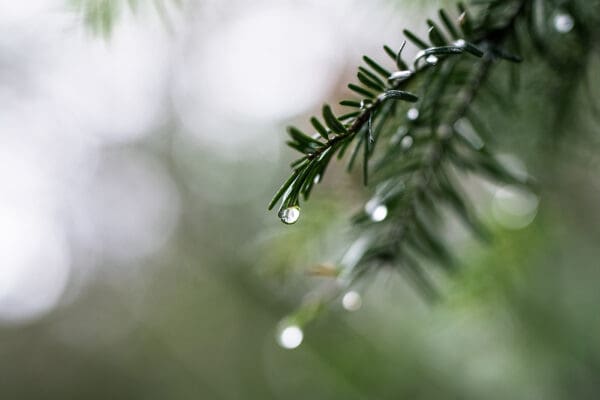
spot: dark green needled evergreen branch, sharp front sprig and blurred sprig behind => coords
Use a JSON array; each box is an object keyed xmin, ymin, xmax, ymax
[{"xmin": 269, "ymin": 0, "xmax": 581, "ymax": 310}]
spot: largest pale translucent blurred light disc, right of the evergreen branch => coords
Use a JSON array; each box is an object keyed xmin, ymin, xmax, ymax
[{"xmin": 492, "ymin": 186, "xmax": 539, "ymax": 229}]
